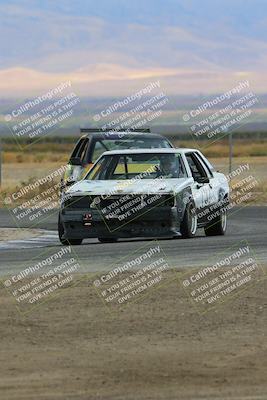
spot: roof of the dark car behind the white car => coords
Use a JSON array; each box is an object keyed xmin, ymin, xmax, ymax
[{"xmin": 82, "ymin": 131, "xmax": 170, "ymax": 143}]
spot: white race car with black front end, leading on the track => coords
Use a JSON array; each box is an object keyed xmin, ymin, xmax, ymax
[{"xmin": 58, "ymin": 148, "xmax": 229, "ymax": 245}]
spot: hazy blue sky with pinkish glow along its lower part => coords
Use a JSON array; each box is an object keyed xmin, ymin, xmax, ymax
[{"xmin": 0, "ymin": 0, "xmax": 267, "ymax": 97}]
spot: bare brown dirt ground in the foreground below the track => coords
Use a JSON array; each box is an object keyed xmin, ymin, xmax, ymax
[{"xmin": 0, "ymin": 268, "xmax": 267, "ymax": 400}]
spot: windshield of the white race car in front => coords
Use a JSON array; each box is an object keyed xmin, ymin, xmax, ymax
[{"xmin": 85, "ymin": 153, "xmax": 186, "ymax": 180}]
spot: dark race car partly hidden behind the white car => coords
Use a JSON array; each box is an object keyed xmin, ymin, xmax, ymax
[{"xmin": 61, "ymin": 128, "xmax": 173, "ymax": 191}]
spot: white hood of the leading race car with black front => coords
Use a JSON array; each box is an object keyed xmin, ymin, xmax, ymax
[{"xmin": 66, "ymin": 178, "xmax": 193, "ymax": 196}]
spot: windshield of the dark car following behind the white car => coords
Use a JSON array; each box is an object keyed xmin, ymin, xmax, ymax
[{"xmin": 93, "ymin": 137, "xmax": 171, "ymax": 162}]
